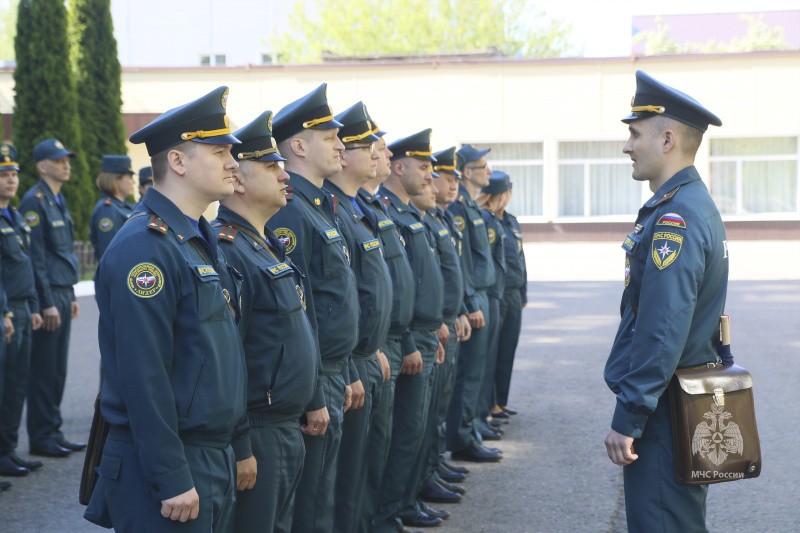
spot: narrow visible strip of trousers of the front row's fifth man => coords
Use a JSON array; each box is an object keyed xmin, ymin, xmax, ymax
[{"xmin": 357, "ymin": 339, "xmax": 403, "ymax": 533}]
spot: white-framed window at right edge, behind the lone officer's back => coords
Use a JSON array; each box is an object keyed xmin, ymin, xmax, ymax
[{"xmin": 709, "ymin": 137, "xmax": 798, "ymax": 215}]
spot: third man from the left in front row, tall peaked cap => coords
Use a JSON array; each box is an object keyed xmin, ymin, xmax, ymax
[{"xmin": 269, "ymin": 84, "xmax": 360, "ymax": 533}]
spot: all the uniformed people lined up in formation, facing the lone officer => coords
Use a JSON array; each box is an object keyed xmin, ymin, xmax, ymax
[{"xmin": 0, "ymin": 84, "xmax": 527, "ymax": 533}]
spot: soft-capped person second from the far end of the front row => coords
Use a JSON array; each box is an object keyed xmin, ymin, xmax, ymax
[{"xmin": 475, "ymin": 176, "xmax": 506, "ymax": 440}]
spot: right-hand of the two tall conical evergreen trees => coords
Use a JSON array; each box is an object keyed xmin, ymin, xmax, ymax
[{"xmin": 70, "ymin": 0, "xmax": 127, "ymax": 184}]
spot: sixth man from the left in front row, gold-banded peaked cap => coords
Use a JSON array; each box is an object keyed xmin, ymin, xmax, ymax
[{"xmin": 376, "ymin": 129, "xmax": 444, "ymax": 532}]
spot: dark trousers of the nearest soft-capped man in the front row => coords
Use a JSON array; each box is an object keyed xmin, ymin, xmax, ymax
[{"xmin": 447, "ymin": 291, "xmax": 490, "ymax": 452}]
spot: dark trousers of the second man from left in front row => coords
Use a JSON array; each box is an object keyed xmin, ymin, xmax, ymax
[{"xmin": 233, "ymin": 420, "xmax": 305, "ymax": 533}]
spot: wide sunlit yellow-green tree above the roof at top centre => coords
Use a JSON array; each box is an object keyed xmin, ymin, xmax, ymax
[{"xmin": 273, "ymin": 0, "xmax": 572, "ymax": 63}]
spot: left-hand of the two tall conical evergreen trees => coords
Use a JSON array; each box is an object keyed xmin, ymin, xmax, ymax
[{"xmin": 14, "ymin": 0, "xmax": 95, "ymax": 238}]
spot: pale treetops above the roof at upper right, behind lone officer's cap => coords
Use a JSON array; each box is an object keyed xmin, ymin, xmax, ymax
[{"xmin": 633, "ymin": 14, "xmax": 789, "ymax": 56}]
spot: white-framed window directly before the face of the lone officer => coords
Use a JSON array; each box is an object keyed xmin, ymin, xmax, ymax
[{"xmin": 558, "ymin": 141, "xmax": 643, "ymax": 217}]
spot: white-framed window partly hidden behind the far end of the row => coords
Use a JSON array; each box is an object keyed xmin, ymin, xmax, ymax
[{"xmin": 472, "ymin": 142, "xmax": 544, "ymax": 216}]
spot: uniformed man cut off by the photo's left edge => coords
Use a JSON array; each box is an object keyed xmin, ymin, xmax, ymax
[{"xmin": 0, "ymin": 143, "xmax": 42, "ymax": 477}]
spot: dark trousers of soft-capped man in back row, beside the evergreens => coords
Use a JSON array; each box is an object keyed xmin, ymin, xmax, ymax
[{"xmin": 27, "ymin": 287, "xmax": 75, "ymax": 448}]
